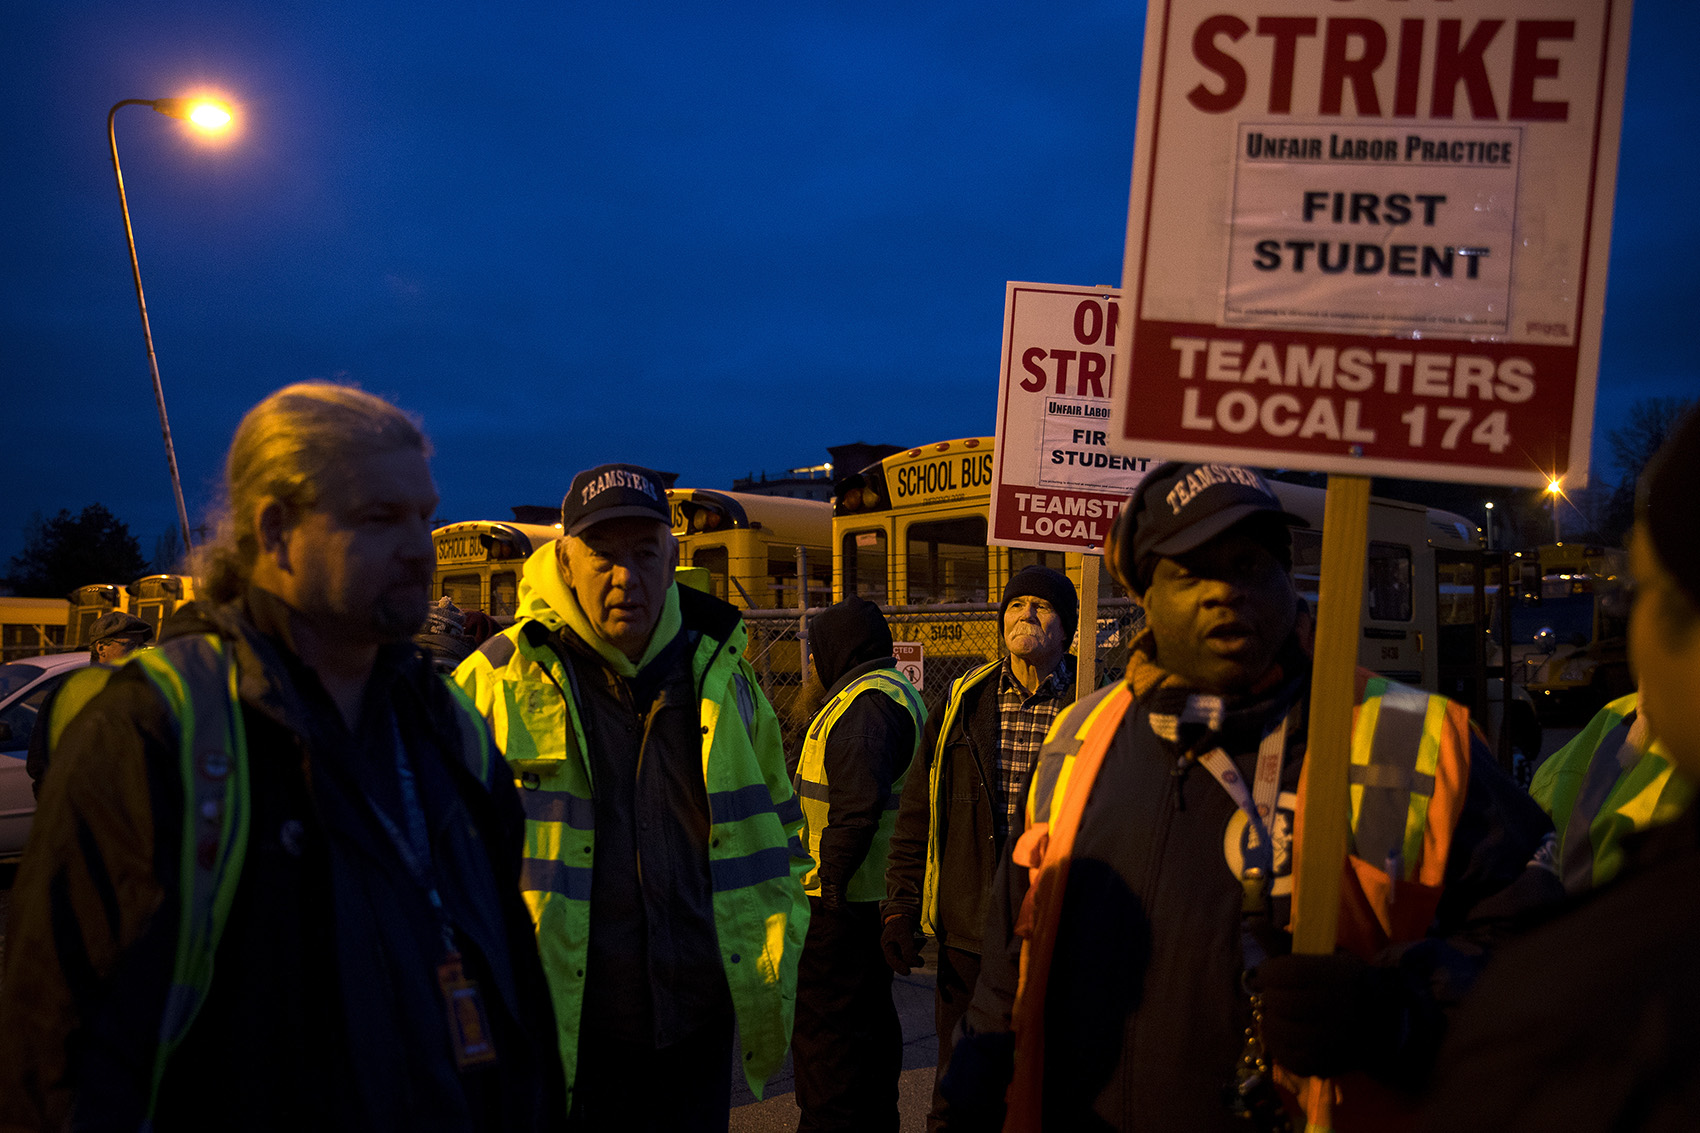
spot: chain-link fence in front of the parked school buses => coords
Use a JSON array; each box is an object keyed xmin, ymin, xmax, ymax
[{"xmin": 743, "ymin": 599, "xmax": 1144, "ymax": 760}]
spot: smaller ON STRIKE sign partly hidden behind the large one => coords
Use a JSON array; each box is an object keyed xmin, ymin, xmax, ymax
[{"xmin": 988, "ymin": 282, "xmax": 1156, "ymax": 555}]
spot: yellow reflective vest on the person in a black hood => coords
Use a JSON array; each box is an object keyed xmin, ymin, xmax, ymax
[{"xmin": 792, "ymin": 669, "xmax": 927, "ymax": 902}]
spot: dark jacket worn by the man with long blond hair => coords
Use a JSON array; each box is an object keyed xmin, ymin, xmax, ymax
[{"xmin": 0, "ymin": 590, "xmax": 561, "ymax": 1133}]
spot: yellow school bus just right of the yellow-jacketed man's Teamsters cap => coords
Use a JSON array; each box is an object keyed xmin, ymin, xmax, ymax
[{"xmin": 666, "ymin": 488, "xmax": 833, "ymax": 609}]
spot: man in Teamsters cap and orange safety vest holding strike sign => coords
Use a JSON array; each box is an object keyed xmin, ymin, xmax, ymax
[{"xmin": 944, "ymin": 463, "xmax": 1549, "ymax": 1130}]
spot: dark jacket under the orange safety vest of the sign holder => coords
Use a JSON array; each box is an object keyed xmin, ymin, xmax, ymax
[{"xmin": 947, "ymin": 665, "xmax": 1550, "ymax": 1133}]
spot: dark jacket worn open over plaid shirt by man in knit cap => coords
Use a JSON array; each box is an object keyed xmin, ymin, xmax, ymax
[{"xmin": 881, "ymin": 653, "xmax": 1074, "ymax": 953}]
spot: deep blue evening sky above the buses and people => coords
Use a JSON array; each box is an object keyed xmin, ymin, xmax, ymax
[{"xmin": 0, "ymin": 0, "xmax": 1700, "ymax": 570}]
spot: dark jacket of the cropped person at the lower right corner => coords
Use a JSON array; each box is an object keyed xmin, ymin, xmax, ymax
[{"xmin": 1425, "ymin": 792, "xmax": 1700, "ymax": 1133}]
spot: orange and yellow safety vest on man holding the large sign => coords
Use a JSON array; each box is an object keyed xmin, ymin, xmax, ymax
[{"xmin": 1003, "ymin": 669, "xmax": 1471, "ymax": 1133}]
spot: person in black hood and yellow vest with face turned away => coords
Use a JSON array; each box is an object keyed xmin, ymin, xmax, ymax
[{"xmin": 792, "ymin": 597, "xmax": 927, "ymax": 1133}]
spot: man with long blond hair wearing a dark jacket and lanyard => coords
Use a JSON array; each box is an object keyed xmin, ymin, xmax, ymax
[{"xmin": 0, "ymin": 383, "xmax": 559, "ymax": 1133}]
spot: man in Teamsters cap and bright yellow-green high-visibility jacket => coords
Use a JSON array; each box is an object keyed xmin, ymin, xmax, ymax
[{"xmin": 456, "ymin": 464, "xmax": 809, "ymax": 1131}]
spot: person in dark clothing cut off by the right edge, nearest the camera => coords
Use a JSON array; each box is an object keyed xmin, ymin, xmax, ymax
[{"xmin": 1428, "ymin": 401, "xmax": 1700, "ymax": 1133}]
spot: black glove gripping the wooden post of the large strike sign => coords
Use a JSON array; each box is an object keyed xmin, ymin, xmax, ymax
[{"xmin": 1246, "ymin": 953, "xmax": 1406, "ymax": 1079}]
